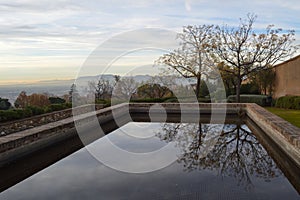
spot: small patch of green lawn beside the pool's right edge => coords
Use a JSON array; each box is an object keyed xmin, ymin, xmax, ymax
[{"xmin": 265, "ymin": 107, "xmax": 300, "ymax": 128}]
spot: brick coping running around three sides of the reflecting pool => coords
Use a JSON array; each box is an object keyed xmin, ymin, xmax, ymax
[{"xmin": 0, "ymin": 103, "xmax": 300, "ymax": 166}]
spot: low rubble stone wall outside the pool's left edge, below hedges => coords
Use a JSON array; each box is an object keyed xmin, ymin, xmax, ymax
[{"xmin": 0, "ymin": 104, "xmax": 104, "ymax": 137}]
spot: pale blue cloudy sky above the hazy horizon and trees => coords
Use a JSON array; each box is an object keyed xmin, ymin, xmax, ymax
[{"xmin": 0, "ymin": 0, "xmax": 300, "ymax": 85}]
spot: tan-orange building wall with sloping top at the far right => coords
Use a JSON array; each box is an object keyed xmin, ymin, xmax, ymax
[{"xmin": 273, "ymin": 55, "xmax": 300, "ymax": 98}]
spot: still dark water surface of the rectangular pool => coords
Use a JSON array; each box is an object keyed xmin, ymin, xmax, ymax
[{"xmin": 0, "ymin": 122, "xmax": 299, "ymax": 200}]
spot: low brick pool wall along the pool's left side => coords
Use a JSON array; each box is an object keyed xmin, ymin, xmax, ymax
[{"xmin": 0, "ymin": 104, "xmax": 128, "ymax": 166}]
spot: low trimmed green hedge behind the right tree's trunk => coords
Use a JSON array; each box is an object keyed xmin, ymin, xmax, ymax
[{"xmin": 227, "ymin": 94, "xmax": 272, "ymax": 106}]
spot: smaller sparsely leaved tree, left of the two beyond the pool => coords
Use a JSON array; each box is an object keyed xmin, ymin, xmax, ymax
[{"xmin": 157, "ymin": 25, "xmax": 213, "ymax": 97}]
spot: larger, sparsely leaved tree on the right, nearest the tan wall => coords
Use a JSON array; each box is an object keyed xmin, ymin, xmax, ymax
[{"xmin": 212, "ymin": 14, "xmax": 297, "ymax": 102}]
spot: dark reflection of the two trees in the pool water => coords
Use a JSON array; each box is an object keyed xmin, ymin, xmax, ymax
[{"xmin": 157, "ymin": 120, "xmax": 281, "ymax": 189}]
